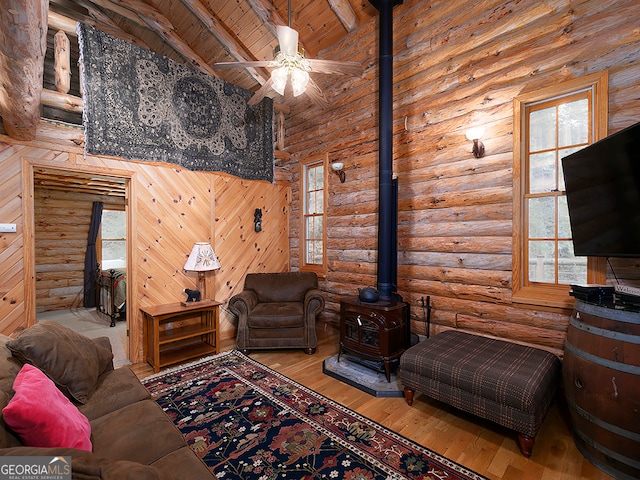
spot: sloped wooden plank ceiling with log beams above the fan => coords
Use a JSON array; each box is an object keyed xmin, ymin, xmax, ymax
[{"xmin": 49, "ymin": 0, "xmax": 377, "ymax": 91}]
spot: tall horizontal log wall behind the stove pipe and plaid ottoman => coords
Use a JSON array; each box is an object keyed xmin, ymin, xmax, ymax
[{"xmin": 284, "ymin": 0, "xmax": 640, "ymax": 355}]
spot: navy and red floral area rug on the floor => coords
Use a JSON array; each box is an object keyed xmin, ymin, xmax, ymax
[{"xmin": 143, "ymin": 351, "xmax": 485, "ymax": 480}]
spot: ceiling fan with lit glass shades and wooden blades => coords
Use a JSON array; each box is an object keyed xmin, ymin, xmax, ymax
[{"xmin": 212, "ymin": 0, "xmax": 364, "ymax": 107}]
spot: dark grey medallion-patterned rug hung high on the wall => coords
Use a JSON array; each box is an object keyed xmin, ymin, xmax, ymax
[{"xmin": 78, "ymin": 24, "xmax": 274, "ymax": 181}]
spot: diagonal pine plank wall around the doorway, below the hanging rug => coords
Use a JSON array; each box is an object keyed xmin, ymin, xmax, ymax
[{"xmin": 0, "ymin": 135, "xmax": 290, "ymax": 361}]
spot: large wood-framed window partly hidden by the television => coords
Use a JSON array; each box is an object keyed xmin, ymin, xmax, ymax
[{"xmin": 513, "ymin": 73, "xmax": 607, "ymax": 308}]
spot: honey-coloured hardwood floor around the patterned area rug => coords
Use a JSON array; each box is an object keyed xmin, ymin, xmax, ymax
[{"xmin": 125, "ymin": 325, "xmax": 612, "ymax": 480}]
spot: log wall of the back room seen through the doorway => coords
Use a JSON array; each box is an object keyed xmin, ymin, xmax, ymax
[{"xmin": 33, "ymin": 188, "xmax": 124, "ymax": 312}]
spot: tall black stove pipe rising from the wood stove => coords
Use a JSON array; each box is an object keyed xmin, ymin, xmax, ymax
[{"xmin": 371, "ymin": 0, "xmax": 402, "ymax": 301}]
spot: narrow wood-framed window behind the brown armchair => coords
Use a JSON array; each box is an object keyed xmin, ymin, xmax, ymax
[{"xmin": 300, "ymin": 155, "xmax": 328, "ymax": 275}]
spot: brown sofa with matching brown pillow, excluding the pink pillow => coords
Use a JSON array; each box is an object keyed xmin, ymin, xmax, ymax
[{"xmin": 0, "ymin": 322, "xmax": 214, "ymax": 480}]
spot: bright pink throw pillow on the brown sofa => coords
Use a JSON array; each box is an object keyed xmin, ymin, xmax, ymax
[{"xmin": 2, "ymin": 363, "xmax": 91, "ymax": 451}]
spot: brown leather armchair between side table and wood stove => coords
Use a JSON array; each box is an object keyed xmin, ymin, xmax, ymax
[{"xmin": 229, "ymin": 272, "xmax": 324, "ymax": 355}]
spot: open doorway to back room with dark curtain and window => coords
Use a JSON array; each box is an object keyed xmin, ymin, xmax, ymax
[{"xmin": 32, "ymin": 166, "xmax": 131, "ymax": 366}]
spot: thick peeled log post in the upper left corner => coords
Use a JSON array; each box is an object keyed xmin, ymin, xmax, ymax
[{"xmin": 0, "ymin": 0, "xmax": 49, "ymax": 140}]
